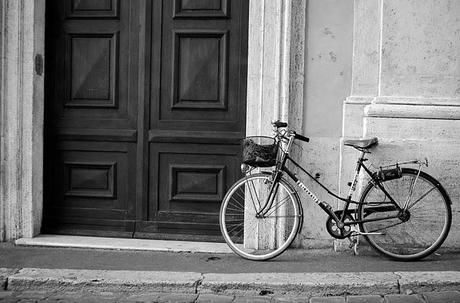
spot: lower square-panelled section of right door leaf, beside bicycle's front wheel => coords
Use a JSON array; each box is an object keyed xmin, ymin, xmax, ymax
[{"xmin": 138, "ymin": 143, "xmax": 240, "ymax": 240}]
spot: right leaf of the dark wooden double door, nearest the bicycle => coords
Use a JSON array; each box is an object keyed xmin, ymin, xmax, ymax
[{"xmin": 136, "ymin": 0, "xmax": 248, "ymax": 240}]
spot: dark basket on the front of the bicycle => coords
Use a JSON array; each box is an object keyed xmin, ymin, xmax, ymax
[{"xmin": 243, "ymin": 136, "xmax": 278, "ymax": 167}]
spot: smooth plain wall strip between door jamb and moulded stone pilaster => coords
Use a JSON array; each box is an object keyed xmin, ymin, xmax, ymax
[{"xmin": 292, "ymin": 0, "xmax": 353, "ymax": 247}]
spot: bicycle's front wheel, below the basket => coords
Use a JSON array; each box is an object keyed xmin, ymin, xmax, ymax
[{"xmin": 219, "ymin": 173, "xmax": 302, "ymax": 261}]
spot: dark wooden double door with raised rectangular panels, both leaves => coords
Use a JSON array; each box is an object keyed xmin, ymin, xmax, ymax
[{"xmin": 43, "ymin": 0, "xmax": 248, "ymax": 240}]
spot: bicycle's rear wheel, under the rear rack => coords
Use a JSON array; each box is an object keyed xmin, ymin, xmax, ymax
[{"xmin": 358, "ymin": 168, "xmax": 452, "ymax": 261}]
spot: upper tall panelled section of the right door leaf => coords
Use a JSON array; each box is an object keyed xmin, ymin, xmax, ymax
[{"xmin": 150, "ymin": 0, "xmax": 248, "ymax": 137}]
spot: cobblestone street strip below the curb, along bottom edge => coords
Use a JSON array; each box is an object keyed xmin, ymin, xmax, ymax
[{"xmin": 0, "ymin": 291, "xmax": 460, "ymax": 303}]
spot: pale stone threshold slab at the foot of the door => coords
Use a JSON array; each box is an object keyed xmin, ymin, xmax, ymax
[{"xmin": 15, "ymin": 235, "xmax": 232, "ymax": 253}]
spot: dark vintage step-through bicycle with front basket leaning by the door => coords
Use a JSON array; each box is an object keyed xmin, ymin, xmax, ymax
[{"xmin": 219, "ymin": 121, "xmax": 452, "ymax": 261}]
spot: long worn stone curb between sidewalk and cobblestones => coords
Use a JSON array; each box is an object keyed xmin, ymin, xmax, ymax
[{"xmin": 0, "ymin": 268, "xmax": 460, "ymax": 296}]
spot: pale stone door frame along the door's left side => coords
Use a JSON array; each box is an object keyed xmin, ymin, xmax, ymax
[{"xmin": 0, "ymin": 0, "xmax": 45, "ymax": 241}]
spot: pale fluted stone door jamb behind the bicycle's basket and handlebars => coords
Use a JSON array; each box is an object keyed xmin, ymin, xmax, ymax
[{"xmin": 245, "ymin": 0, "xmax": 306, "ymax": 249}]
